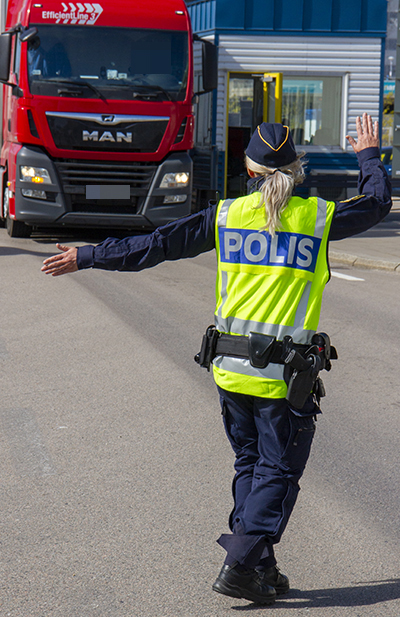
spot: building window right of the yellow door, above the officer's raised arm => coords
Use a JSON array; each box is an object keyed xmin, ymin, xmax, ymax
[{"xmin": 282, "ymin": 77, "xmax": 342, "ymax": 146}]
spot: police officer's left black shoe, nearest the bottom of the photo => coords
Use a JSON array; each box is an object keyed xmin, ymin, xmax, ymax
[{"xmin": 212, "ymin": 563, "xmax": 276, "ymax": 604}]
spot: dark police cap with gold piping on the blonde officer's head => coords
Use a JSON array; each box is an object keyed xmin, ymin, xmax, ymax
[{"xmin": 246, "ymin": 122, "xmax": 297, "ymax": 167}]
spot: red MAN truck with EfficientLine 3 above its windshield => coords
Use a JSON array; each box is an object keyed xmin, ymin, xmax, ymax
[{"xmin": 0, "ymin": 0, "xmax": 217, "ymax": 237}]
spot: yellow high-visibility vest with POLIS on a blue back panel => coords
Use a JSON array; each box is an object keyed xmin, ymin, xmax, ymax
[{"xmin": 213, "ymin": 192, "xmax": 335, "ymax": 398}]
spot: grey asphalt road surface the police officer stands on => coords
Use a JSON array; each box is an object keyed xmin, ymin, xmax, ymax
[{"xmin": 0, "ymin": 229, "xmax": 400, "ymax": 617}]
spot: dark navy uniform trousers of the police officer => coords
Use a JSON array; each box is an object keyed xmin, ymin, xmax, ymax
[{"xmin": 218, "ymin": 388, "xmax": 320, "ymax": 569}]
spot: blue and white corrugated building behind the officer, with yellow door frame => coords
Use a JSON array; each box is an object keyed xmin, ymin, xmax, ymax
[{"xmin": 187, "ymin": 0, "xmax": 387, "ymax": 198}]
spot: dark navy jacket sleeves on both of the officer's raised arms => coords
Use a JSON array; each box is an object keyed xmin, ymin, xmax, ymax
[{"xmin": 77, "ymin": 148, "xmax": 392, "ymax": 271}]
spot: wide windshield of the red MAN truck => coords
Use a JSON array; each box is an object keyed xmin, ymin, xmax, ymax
[{"xmin": 28, "ymin": 24, "xmax": 188, "ymax": 101}]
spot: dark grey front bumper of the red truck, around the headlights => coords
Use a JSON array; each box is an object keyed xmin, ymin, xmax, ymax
[{"xmin": 15, "ymin": 146, "xmax": 193, "ymax": 229}]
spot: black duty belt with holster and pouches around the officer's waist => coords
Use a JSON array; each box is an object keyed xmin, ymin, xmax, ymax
[{"xmin": 194, "ymin": 326, "xmax": 338, "ymax": 409}]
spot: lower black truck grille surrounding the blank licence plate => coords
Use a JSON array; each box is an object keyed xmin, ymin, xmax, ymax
[{"xmin": 54, "ymin": 159, "xmax": 157, "ymax": 214}]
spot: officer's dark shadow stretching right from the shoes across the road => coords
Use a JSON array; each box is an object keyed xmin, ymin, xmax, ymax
[{"xmin": 232, "ymin": 578, "xmax": 400, "ymax": 611}]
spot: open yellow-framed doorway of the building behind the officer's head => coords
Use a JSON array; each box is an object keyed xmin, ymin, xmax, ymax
[{"xmin": 225, "ymin": 73, "xmax": 282, "ymax": 197}]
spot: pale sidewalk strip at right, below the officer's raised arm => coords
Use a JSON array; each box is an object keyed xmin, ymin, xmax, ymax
[{"xmin": 329, "ymin": 198, "xmax": 400, "ymax": 274}]
